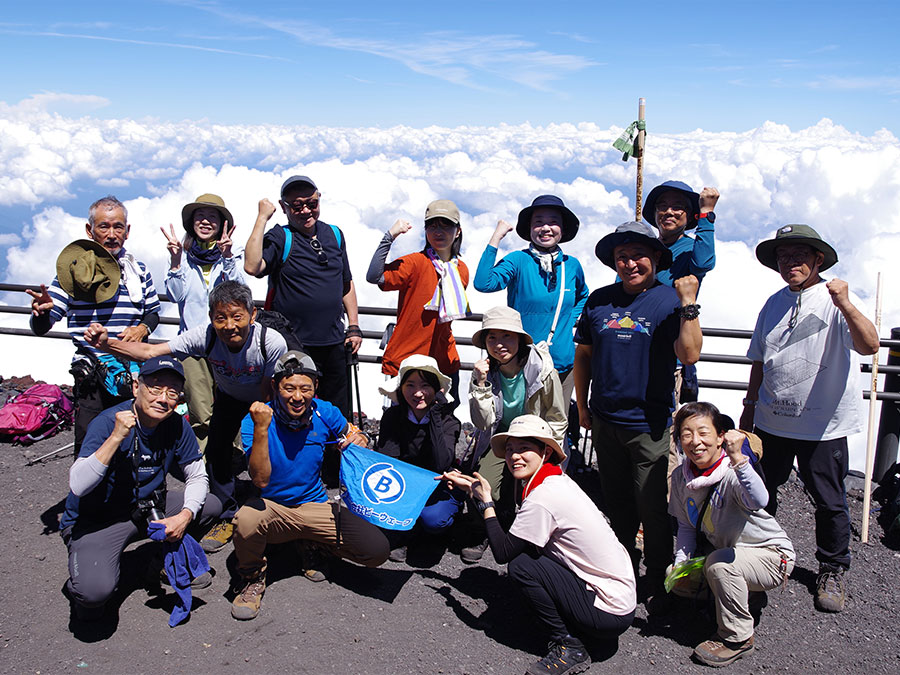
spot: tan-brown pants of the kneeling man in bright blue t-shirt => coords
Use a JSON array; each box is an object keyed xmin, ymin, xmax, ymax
[{"xmin": 234, "ymin": 498, "xmax": 390, "ymax": 577}]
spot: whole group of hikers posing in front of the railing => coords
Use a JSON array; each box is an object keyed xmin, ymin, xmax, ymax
[{"xmin": 29, "ymin": 176, "xmax": 879, "ymax": 673}]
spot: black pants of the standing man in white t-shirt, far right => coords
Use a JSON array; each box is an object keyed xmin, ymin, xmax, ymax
[{"xmin": 756, "ymin": 429, "xmax": 850, "ymax": 568}]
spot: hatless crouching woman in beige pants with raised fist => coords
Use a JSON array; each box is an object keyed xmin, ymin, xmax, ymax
[{"xmin": 669, "ymin": 402, "xmax": 794, "ymax": 667}]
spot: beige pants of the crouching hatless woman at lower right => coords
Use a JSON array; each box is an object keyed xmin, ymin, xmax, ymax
[{"xmin": 703, "ymin": 546, "xmax": 794, "ymax": 642}]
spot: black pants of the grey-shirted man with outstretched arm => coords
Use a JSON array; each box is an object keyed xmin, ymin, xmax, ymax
[{"xmin": 206, "ymin": 389, "xmax": 250, "ymax": 520}]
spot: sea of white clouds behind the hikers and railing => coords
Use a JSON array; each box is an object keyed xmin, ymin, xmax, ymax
[{"xmin": 0, "ymin": 106, "xmax": 900, "ymax": 470}]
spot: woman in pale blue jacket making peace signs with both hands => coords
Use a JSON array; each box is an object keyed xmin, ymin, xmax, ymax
[{"xmin": 159, "ymin": 194, "xmax": 247, "ymax": 455}]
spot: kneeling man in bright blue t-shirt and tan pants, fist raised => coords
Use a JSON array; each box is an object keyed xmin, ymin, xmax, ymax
[{"xmin": 231, "ymin": 351, "xmax": 390, "ymax": 620}]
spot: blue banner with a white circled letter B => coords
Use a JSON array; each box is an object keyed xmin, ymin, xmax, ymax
[{"xmin": 341, "ymin": 445, "xmax": 439, "ymax": 530}]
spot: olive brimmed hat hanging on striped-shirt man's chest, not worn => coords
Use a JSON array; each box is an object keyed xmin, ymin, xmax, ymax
[{"xmin": 56, "ymin": 239, "xmax": 122, "ymax": 304}]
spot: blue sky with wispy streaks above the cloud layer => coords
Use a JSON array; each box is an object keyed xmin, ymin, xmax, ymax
[{"xmin": 0, "ymin": 0, "xmax": 900, "ymax": 135}]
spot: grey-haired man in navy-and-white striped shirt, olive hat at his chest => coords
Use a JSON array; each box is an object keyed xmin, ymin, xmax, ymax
[{"xmin": 27, "ymin": 195, "xmax": 159, "ymax": 457}]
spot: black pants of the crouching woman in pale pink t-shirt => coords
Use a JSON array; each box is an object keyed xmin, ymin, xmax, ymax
[{"xmin": 509, "ymin": 553, "xmax": 634, "ymax": 641}]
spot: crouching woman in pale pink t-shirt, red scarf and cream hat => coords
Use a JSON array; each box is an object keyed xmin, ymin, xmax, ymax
[{"xmin": 444, "ymin": 415, "xmax": 637, "ymax": 674}]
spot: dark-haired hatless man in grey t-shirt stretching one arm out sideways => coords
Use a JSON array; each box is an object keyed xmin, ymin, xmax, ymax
[{"xmin": 84, "ymin": 280, "xmax": 287, "ymax": 553}]
